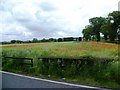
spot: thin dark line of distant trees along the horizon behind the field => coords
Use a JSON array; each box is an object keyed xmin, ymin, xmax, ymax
[{"xmin": 1, "ymin": 37, "xmax": 82, "ymax": 44}]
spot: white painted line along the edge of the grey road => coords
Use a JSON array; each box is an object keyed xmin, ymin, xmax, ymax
[{"xmin": 0, "ymin": 71, "xmax": 110, "ymax": 90}]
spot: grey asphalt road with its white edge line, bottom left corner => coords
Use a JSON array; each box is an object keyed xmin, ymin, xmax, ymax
[{"xmin": 0, "ymin": 71, "xmax": 108, "ymax": 90}]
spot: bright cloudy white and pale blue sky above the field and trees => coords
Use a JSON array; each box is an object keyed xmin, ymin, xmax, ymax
[{"xmin": 0, "ymin": 0, "xmax": 119, "ymax": 41}]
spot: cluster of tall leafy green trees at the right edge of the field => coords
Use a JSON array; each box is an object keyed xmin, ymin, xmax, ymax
[{"xmin": 82, "ymin": 11, "xmax": 120, "ymax": 42}]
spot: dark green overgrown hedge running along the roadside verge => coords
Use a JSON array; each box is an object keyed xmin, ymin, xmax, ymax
[{"xmin": 3, "ymin": 57, "xmax": 120, "ymax": 87}]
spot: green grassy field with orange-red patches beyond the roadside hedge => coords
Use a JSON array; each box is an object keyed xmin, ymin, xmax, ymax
[{"xmin": 1, "ymin": 42, "xmax": 118, "ymax": 58}]
